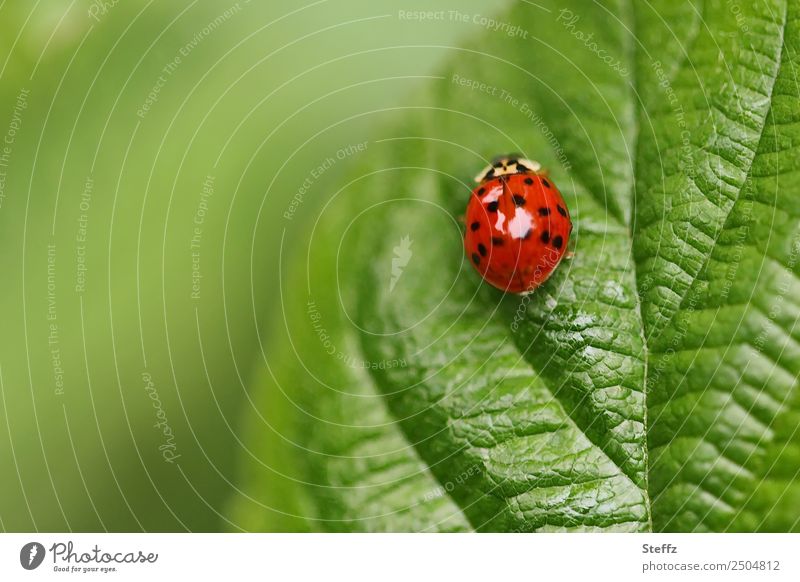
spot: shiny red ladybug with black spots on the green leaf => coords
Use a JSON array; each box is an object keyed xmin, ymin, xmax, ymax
[{"xmin": 464, "ymin": 155, "xmax": 572, "ymax": 294}]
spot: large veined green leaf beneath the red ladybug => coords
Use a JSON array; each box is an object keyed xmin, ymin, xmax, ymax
[{"xmin": 232, "ymin": 0, "xmax": 800, "ymax": 531}]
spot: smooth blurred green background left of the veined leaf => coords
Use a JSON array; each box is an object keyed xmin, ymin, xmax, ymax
[{"xmin": 0, "ymin": 0, "xmax": 504, "ymax": 531}]
